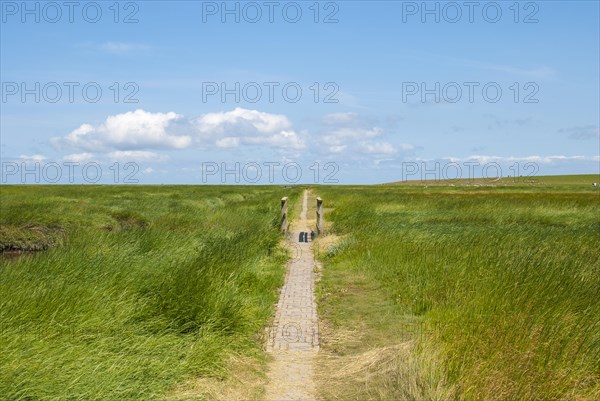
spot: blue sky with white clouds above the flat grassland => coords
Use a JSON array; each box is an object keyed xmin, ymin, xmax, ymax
[{"xmin": 0, "ymin": 1, "xmax": 600, "ymax": 184}]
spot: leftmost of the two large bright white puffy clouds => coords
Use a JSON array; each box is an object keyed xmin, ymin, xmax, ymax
[{"xmin": 52, "ymin": 109, "xmax": 192, "ymax": 151}]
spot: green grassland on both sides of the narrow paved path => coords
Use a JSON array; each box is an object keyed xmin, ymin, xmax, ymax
[{"xmin": 0, "ymin": 176, "xmax": 600, "ymax": 401}]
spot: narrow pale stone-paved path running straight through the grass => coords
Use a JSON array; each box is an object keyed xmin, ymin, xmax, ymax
[{"xmin": 266, "ymin": 191, "xmax": 319, "ymax": 401}]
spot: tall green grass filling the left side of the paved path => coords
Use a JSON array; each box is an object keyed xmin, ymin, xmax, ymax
[{"xmin": 0, "ymin": 186, "xmax": 299, "ymax": 400}]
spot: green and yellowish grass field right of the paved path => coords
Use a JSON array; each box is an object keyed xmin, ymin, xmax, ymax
[{"xmin": 318, "ymin": 180, "xmax": 600, "ymax": 401}]
